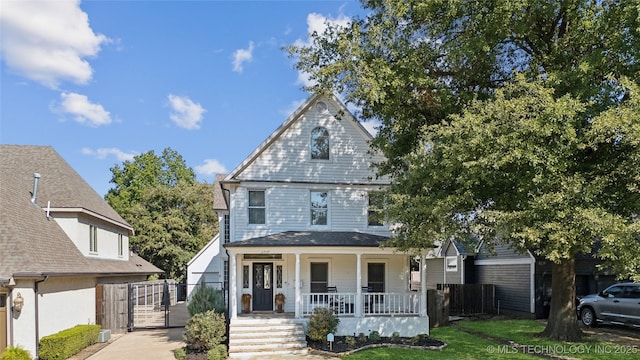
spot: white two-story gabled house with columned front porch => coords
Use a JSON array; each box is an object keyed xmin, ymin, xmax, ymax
[{"xmin": 188, "ymin": 95, "xmax": 429, "ymax": 341}]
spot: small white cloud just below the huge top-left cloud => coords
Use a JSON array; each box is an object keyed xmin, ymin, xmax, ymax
[{"xmin": 54, "ymin": 93, "xmax": 111, "ymax": 127}]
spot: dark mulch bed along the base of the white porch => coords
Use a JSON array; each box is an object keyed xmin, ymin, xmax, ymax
[{"xmin": 307, "ymin": 336, "xmax": 446, "ymax": 356}]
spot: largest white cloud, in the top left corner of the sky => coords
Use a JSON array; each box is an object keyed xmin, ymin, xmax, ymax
[{"xmin": 0, "ymin": 0, "xmax": 109, "ymax": 89}]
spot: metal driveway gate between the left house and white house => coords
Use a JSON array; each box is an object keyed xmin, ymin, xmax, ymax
[{"xmin": 128, "ymin": 280, "xmax": 189, "ymax": 331}]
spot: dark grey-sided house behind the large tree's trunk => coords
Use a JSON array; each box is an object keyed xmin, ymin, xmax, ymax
[{"xmin": 427, "ymin": 240, "xmax": 615, "ymax": 318}]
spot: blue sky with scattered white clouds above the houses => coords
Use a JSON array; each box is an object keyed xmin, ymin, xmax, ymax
[{"xmin": 0, "ymin": 0, "xmax": 374, "ymax": 196}]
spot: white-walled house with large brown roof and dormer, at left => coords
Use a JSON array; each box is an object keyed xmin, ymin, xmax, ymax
[{"xmin": 0, "ymin": 145, "xmax": 162, "ymax": 356}]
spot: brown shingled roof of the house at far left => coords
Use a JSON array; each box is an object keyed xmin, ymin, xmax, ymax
[{"xmin": 0, "ymin": 145, "xmax": 162, "ymax": 280}]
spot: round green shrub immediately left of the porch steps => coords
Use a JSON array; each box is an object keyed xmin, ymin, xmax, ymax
[{"xmin": 184, "ymin": 310, "xmax": 227, "ymax": 352}]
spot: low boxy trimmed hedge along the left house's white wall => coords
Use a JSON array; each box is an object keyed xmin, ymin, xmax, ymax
[{"xmin": 40, "ymin": 325, "xmax": 100, "ymax": 360}]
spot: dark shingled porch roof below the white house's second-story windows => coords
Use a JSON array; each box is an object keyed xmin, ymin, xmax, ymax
[{"xmin": 224, "ymin": 231, "xmax": 389, "ymax": 248}]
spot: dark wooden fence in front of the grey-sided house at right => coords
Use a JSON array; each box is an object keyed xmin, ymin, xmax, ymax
[{"xmin": 438, "ymin": 284, "xmax": 496, "ymax": 316}]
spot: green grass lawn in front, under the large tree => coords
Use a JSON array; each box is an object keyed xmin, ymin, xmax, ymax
[{"xmin": 344, "ymin": 320, "xmax": 640, "ymax": 360}]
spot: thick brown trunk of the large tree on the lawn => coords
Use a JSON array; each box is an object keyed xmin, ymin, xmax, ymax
[{"xmin": 540, "ymin": 259, "xmax": 582, "ymax": 342}]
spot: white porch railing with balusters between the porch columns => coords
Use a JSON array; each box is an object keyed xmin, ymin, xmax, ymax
[{"xmin": 301, "ymin": 292, "xmax": 420, "ymax": 316}]
